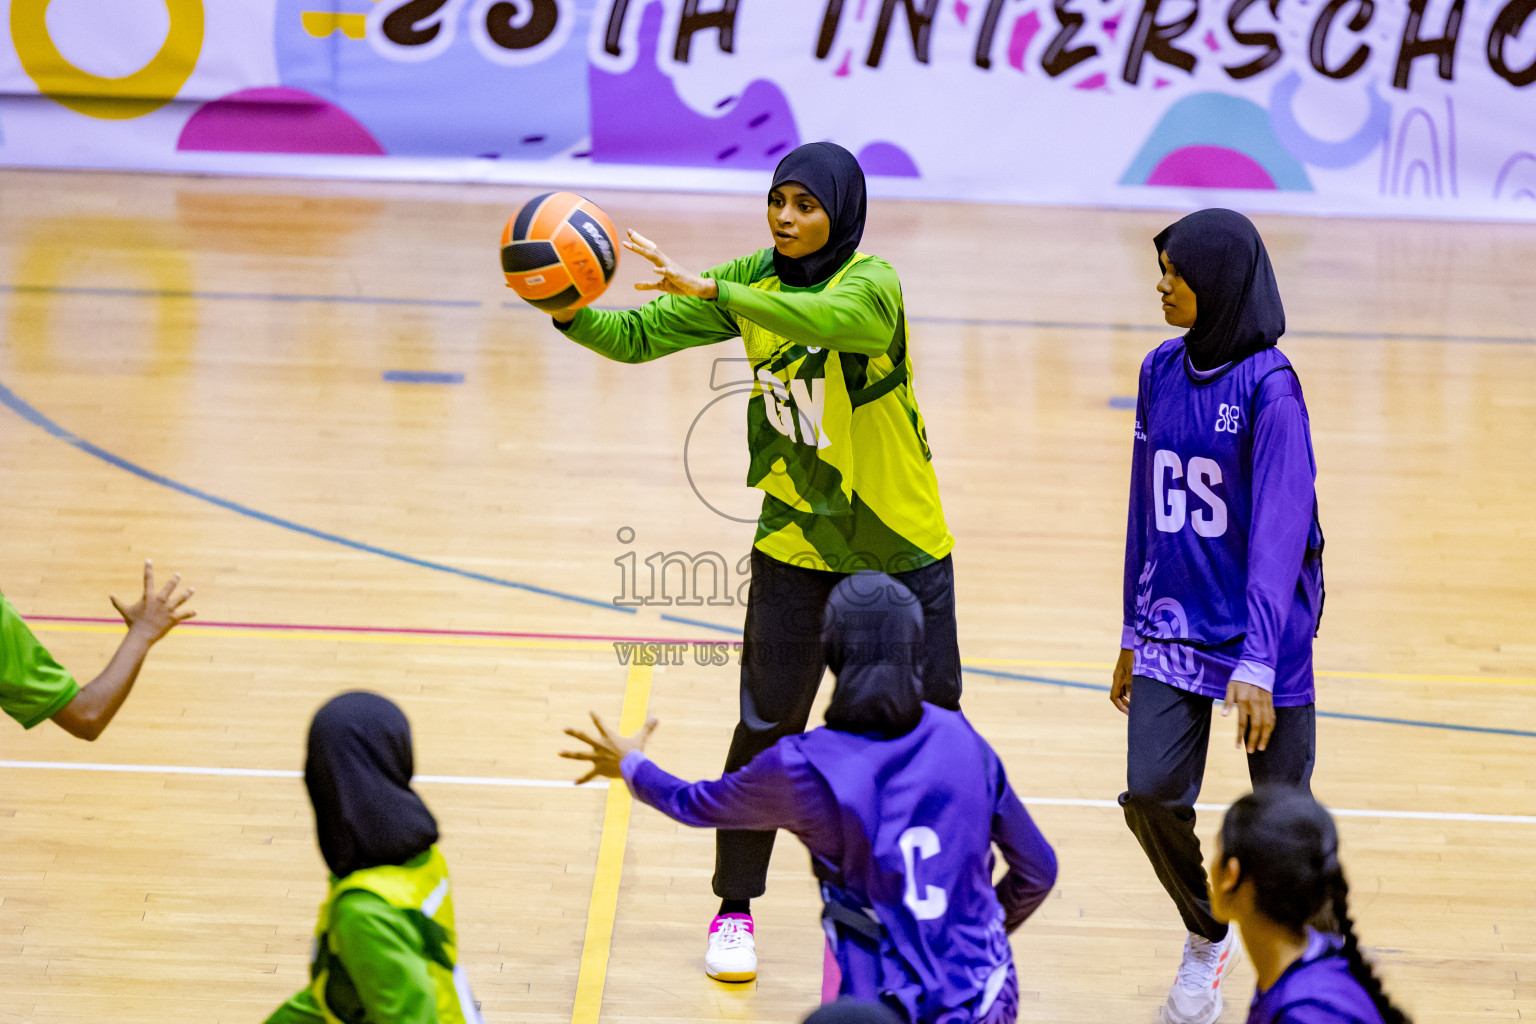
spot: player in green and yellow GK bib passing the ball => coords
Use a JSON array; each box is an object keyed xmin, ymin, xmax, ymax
[{"xmin": 554, "ymin": 143, "xmax": 960, "ymax": 981}]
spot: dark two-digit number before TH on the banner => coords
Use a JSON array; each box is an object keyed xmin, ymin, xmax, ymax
[{"xmin": 367, "ymin": 0, "xmax": 576, "ymax": 66}]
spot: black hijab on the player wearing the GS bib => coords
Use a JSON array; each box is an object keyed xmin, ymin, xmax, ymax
[{"xmin": 1154, "ymin": 210, "xmax": 1286, "ymax": 370}]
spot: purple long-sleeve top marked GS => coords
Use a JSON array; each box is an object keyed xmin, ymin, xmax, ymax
[{"xmin": 1121, "ymin": 338, "xmax": 1322, "ymax": 706}]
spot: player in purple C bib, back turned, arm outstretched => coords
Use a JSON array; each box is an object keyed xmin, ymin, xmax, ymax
[{"xmin": 562, "ymin": 573, "xmax": 1057, "ymax": 1024}]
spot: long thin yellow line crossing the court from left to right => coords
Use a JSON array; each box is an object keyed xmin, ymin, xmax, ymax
[{"xmin": 28, "ymin": 622, "xmax": 1536, "ymax": 686}]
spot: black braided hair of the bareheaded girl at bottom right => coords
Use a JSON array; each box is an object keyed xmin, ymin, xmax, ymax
[{"xmin": 1221, "ymin": 786, "xmax": 1412, "ymax": 1024}]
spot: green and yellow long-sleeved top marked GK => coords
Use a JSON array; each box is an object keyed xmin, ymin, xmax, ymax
[{"xmin": 561, "ymin": 249, "xmax": 954, "ymax": 573}]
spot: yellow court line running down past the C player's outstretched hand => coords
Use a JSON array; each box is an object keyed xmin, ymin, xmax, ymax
[{"xmin": 571, "ymin": 665, "xmax": 653, "ymax": 1024}]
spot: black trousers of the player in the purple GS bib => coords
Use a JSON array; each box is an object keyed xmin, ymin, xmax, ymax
[{"xmin": 1120, "ymin": 676, "xmax": 1318, "ymax": 941}]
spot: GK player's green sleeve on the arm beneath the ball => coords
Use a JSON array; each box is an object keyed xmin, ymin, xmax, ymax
[{"xmin": 556, "ymin": 252, "xmax": 763, "ymax": 362}]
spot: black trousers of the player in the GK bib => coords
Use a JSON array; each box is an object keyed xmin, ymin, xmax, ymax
[{"xmin": 714, "ymin": 548, "xmax": 960, "ymax": 900}]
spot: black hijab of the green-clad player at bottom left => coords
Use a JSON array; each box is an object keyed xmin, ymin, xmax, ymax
[{"xmin": 304, "ymin": 691, "xmax": 438, "ymax": 878}]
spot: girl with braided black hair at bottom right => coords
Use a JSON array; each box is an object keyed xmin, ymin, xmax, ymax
[{"xmin": 1210, "ymin": 786, "xmax": 1412, "ymax": 1024}]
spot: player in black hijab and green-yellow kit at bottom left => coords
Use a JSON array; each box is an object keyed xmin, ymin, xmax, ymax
[{"xmin": 267, "ymin": 691, "xmax": 481, "ymax": 1024}]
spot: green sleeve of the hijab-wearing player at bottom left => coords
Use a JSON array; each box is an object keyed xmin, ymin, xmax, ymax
[{"xmin": 330, "ymin": 890, "xmax": 438, "ymax": 1024}]
